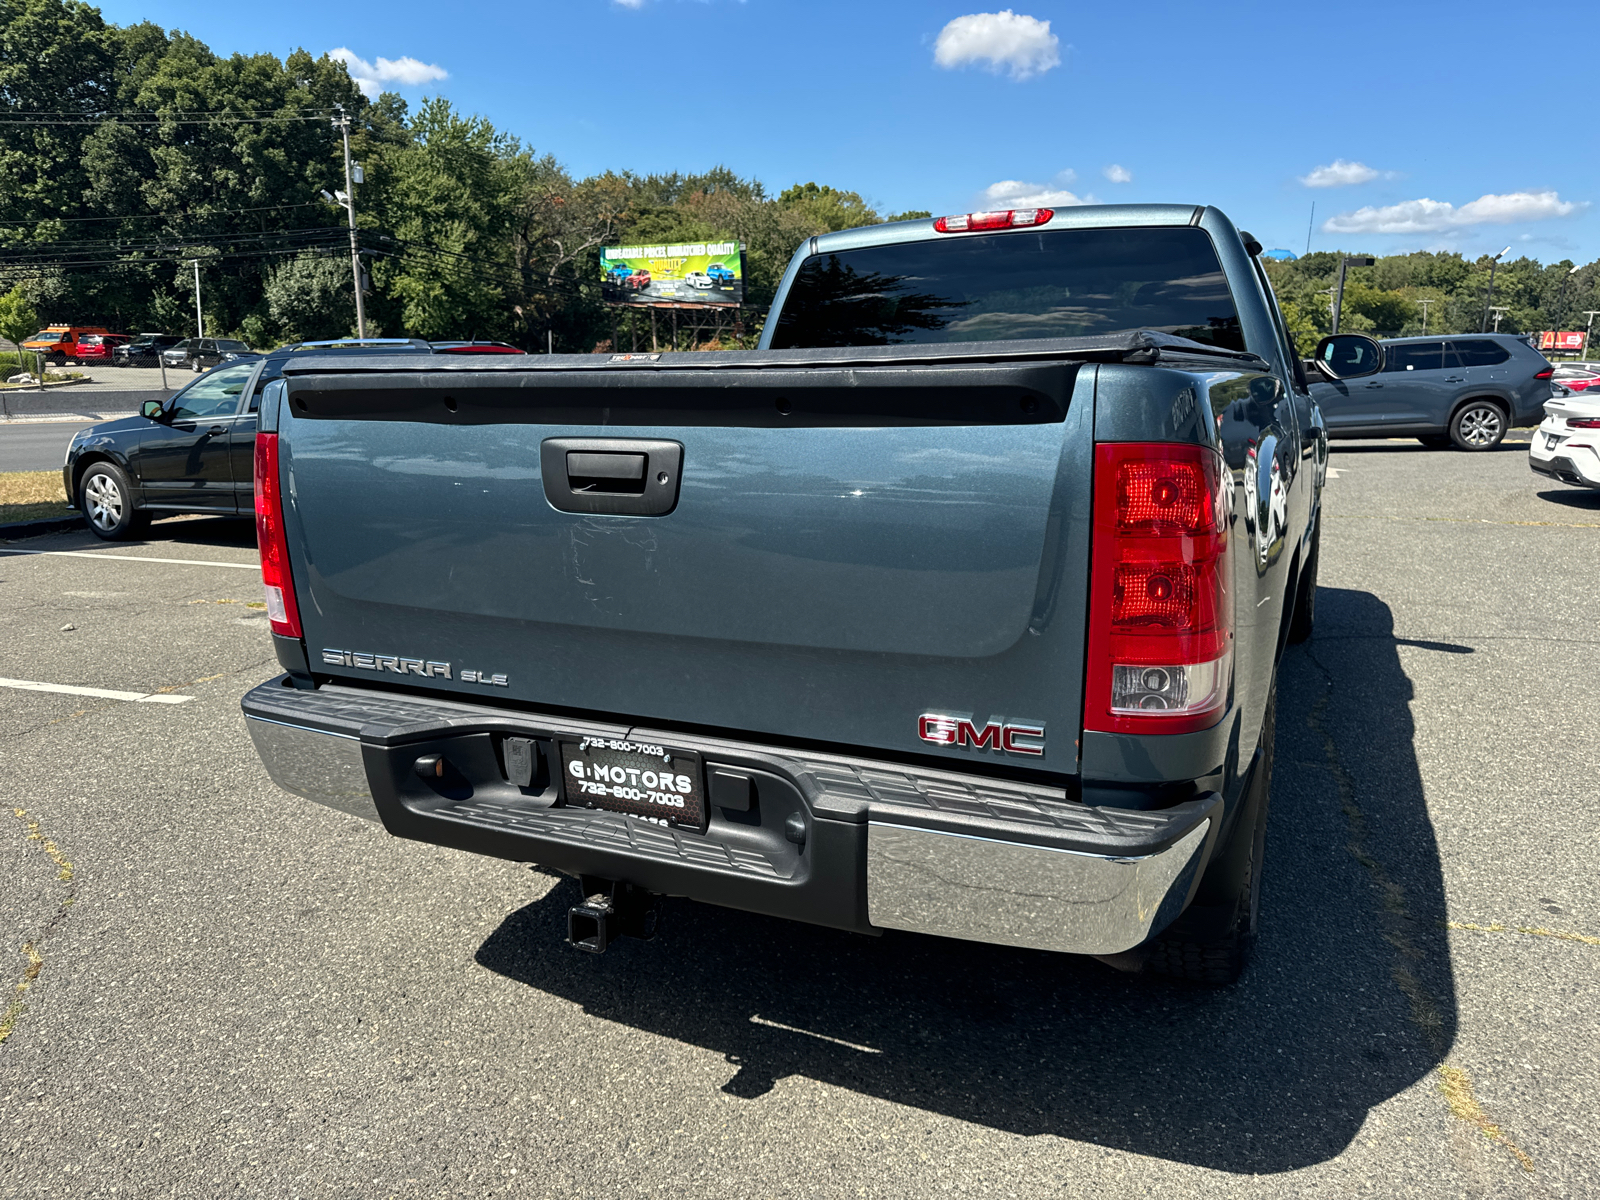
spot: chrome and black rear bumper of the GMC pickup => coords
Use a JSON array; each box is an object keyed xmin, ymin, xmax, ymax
[{"xmin": 242, "ymin": 675, "xmax": 1222, "ymax": 954}]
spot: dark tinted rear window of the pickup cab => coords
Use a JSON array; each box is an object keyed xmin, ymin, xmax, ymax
[{"xmin": 773, "ymin": 226, "xmax": 1245, "ymax": 350}]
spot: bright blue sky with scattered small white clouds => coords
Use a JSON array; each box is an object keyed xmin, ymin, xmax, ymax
[{"xmin": 101, "ymin": 0, "xmax": 1600, "ymax": 262}]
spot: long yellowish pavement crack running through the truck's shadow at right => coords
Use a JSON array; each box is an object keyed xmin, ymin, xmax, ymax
[{"xmin": 1306, "ymin": 646, "xmax": 1536, "ymax": 1173}]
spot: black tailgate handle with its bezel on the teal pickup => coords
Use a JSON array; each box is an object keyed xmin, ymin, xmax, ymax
[{"xmin": 539, "ymin": 437, "xmax": 683, "ymax": 517}]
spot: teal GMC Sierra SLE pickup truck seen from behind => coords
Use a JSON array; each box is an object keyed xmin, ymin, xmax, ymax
[{"xmin": 243, "ymin": 205, "xmax": 1382, "ymax": 984}]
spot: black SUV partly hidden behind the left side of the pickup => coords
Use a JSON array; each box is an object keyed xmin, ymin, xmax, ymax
[{"xmin": 62, "ymin": 338, "xmax": 483, "ymax": 541}]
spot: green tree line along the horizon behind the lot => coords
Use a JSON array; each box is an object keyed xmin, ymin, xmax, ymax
[{"xmin": 0, "ymin": 0, "xmax": 1600, "ymax": 350}]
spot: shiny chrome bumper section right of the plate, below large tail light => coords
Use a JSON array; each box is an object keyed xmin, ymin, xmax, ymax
[{"xmin": 867, "ymin": 821, "xmax": 1211, "ymax": 954}]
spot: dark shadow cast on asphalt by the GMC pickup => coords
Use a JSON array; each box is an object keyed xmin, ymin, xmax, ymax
[{"xmin": 477, "ymin": 589, "xmax": 1456, "ymax": 1173}]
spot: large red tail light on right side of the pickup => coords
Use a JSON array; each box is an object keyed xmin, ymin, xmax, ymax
[{"xmin": 1083, "ymin": 442, "xmax": 1234, "ymax": 733}]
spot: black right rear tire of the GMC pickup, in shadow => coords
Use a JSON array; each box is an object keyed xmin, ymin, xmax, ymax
[{"xmin": 1144, "ymin": 683, "xmax": 1278, "ymax": 987}]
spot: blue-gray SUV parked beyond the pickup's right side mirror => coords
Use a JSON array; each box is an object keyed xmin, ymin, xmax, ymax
[{"xmin": 1312, "ymin": 333, "xmax": 1555, "ymax": 450}]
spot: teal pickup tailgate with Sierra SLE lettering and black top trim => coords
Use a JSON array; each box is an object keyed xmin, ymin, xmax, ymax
[{"xmin": 275, "ymin": 355, "xmax": 1094, "ymax": 771}]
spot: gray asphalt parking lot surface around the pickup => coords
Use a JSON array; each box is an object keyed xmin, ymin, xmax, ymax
[{"xmin": 0, "ymin": 442, "xmax": 1600, "ymax": 1197}]
